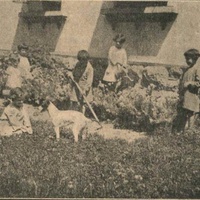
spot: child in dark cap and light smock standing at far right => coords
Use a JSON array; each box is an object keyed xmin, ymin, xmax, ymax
[{"xmin": 172, "ymin": 49, "xmax": 200, "ymax": 133}]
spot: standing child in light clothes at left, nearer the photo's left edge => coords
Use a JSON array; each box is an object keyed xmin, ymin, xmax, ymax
[{"xmin": 6, "ymin": 54, "xmax": 22, "ymax": 89}]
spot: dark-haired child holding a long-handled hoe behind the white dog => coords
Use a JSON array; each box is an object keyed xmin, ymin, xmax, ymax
[{"xmin": 68, "ymin": 50, "xmax": 94, "ymax": 113}]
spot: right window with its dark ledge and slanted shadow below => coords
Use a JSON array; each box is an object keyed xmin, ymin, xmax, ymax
[{"xmin": 89, "ymin": 1, "xmax": 176, "ymax": 58}]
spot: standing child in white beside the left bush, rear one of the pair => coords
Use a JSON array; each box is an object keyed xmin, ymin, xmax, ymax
[{"xmin": 18, "ymin": 44, "xmax": 33, "ymax": 80}]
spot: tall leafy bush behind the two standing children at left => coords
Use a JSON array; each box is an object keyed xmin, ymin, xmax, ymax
[{"xmin": 0, "ymin": 46, "xmax": 70, "ymax": 104}]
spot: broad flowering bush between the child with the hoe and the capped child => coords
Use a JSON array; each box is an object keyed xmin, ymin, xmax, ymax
[{"xmin": 94, "ymin": 85, "xmax": 178, "ymax": 131}]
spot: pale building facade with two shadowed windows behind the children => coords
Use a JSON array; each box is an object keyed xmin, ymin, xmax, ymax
[{"xmin": 0, "ymin": 0, "xmax": 200, "ymax": 65}]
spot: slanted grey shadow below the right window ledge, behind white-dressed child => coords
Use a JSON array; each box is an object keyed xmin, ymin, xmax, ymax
[{"xmin": 89, "ymin": 15, "xmax": 174, "ymax": 58}]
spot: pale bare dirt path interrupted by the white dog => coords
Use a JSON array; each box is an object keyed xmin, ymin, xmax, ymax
[{"xmin": 0, "ymin": 99, "xmax": 146, "ymax": 142}]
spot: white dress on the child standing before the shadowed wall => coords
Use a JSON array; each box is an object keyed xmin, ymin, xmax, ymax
[{"xmin": 103, "ymin": 46, "xmax": 127, "ymax": 82}]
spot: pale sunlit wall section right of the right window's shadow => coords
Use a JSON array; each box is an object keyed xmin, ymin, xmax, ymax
[{"xmin": 158, "ymin": 1, "xmax": 200, "ymax": 65}]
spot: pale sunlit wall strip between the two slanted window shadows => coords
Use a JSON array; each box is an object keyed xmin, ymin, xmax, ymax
[{"xmin": 55, "ymin": 1, "xmax": 102, "ymax": 56}]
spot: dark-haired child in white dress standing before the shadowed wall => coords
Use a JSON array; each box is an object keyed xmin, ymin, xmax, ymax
[{"xmin": 103, "ymin": 34, "xmax": 127, "ymax": 88}]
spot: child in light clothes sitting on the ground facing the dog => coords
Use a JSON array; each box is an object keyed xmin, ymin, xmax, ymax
[{"xmin": 0, "ymin": 88, "xmax": 33, "ymax": 136}]
